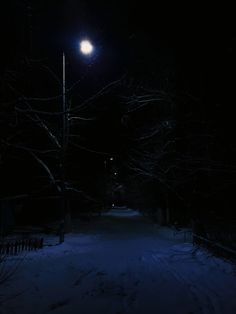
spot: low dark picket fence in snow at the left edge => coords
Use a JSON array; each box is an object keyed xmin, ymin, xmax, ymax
[{"xmin": 0, "ymin": 238, "xmax": 44, "ymax": 255}]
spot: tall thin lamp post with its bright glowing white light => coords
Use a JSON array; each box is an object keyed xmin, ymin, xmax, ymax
[{"xmin": 60, "ymin": 39, "xmax": 94, "ymax": 236}]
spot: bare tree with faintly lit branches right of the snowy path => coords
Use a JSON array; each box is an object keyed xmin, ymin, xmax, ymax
[{"xmin": 121, "ymin": 88, "xmax": 236, "ymax": 223}]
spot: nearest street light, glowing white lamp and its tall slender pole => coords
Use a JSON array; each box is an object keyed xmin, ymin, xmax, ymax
[{"xmin": 61, "ymin": 39, "xmax": 94, "ymax": 236}]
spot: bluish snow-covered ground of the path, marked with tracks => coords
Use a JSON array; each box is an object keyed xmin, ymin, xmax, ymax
[{"xmin": 0, "ymin": 209, "xmax": 236, "ymax": 314}]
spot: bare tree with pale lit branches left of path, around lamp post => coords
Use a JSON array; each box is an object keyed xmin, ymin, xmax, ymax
[{"xmin": 1, "ymin": 53, "xmax": 125, "ymax": 230}]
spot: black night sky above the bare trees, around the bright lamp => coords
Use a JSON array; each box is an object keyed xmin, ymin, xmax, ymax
[{"xmin": 1, "ymin": 0, "xmax": 236, "ymax": 98}]
